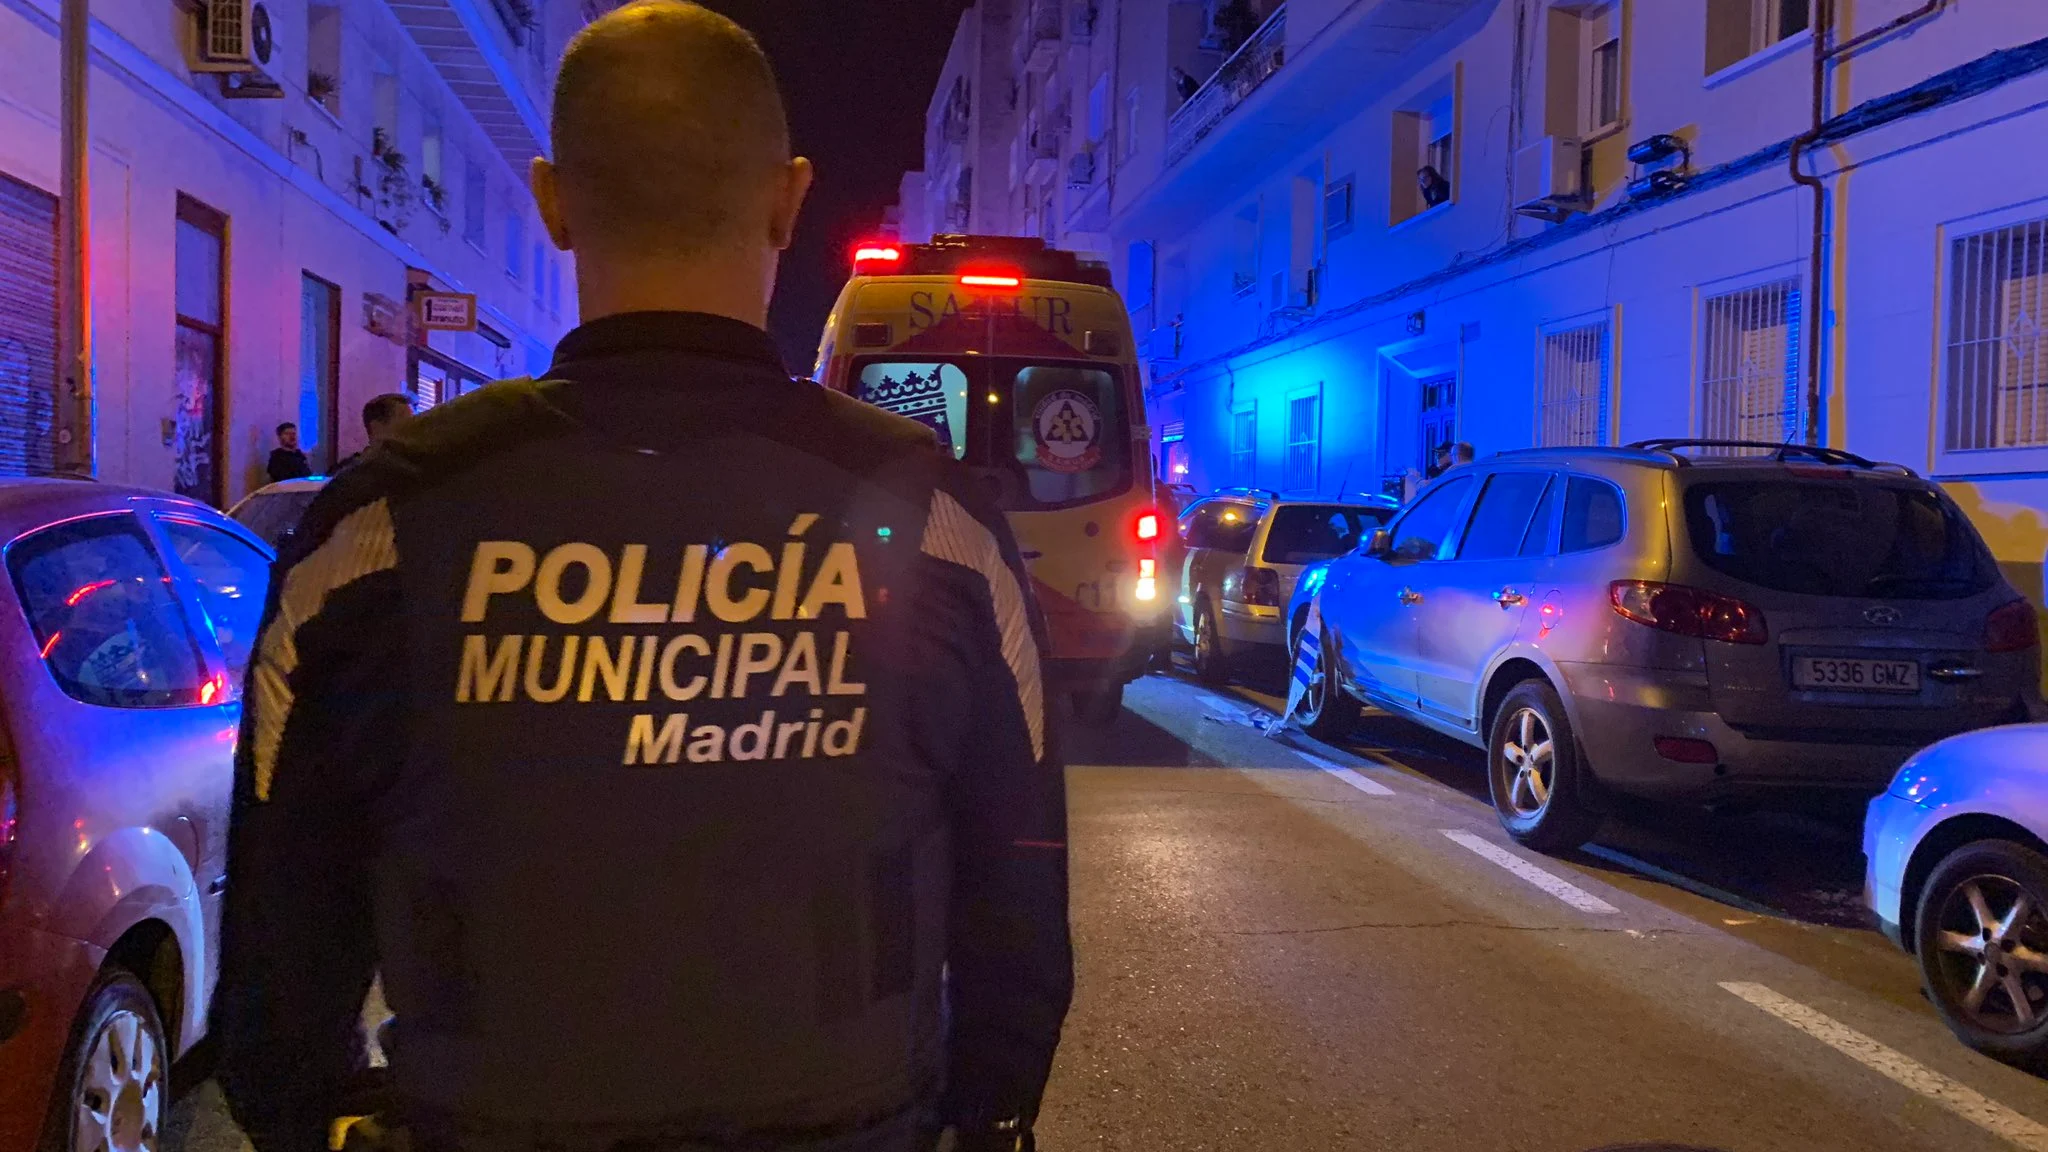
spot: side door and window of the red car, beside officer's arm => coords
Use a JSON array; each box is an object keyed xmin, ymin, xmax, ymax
[{"xmin": 156, "ymin": 512, "xmax": 270, "ymax": 1000}]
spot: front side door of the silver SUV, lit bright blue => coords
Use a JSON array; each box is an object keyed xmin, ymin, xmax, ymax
[{"xmin": 1323, "ymin": 474, "xmax": 1475, "ymax": 709}]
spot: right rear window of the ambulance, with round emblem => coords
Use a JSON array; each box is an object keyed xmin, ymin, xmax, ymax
[{"xmin": 1010, "ymin": 365, "xmax": 1130, "ymax": 508}]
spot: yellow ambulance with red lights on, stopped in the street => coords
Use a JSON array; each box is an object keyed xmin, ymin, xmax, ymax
[{"xmin": 815, "ymin": 236, "xmax": 1169, "ymax": 722}]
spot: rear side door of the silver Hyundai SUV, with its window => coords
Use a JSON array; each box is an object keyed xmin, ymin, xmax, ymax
[{"xmin": 1415, "ymin": 469, "xmax": 1554, "ymax": 732}]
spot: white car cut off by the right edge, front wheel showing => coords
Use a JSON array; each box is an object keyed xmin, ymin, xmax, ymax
[{"xmin": 1864, "ymin": 724, "xmax": 2048, "ymax": 1070}]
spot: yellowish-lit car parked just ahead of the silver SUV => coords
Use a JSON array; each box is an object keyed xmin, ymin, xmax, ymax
[{"xmin": 1174, "ymin": 488, "xmax": 1399, "ymax": 683}]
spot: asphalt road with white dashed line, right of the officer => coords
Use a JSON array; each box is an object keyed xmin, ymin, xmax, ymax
[{"xmin": 168, "ymin": 676, "xmax": 2048, "ymax": 1152}]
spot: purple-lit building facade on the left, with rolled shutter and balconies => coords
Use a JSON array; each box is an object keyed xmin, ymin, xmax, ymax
[{"xmin": 0, "ymin": 0, "xmax": 596, "ymax": 504}]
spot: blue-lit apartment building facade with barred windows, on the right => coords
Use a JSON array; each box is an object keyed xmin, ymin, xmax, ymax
[{"xmin": 1110, "ymin": 0, "xmax": 2048, "ymax": 651}]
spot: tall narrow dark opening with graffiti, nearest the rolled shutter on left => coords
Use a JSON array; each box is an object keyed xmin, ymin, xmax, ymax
[{"xmin": 170, "ymin": 195, "xmax": 227, "ymax": 506}]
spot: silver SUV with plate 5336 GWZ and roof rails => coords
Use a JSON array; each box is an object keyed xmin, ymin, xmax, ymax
[{"xmin": 1288, "ymin": 441, "xmax": 2040, "ymax": 849}]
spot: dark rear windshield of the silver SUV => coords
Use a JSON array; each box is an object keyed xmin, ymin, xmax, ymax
[{"xmin": 1686, "ymin": 480, "xmax": 1999, "ymax": 601}]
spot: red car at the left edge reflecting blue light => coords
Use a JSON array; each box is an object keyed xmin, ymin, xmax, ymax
[{"xmin": 0, "ymin": 480, "xmax": 270, "ymax": 1152}]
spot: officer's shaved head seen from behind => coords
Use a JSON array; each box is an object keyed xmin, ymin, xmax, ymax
[{"xmin": 535, "ymin": 0, "xmax": 811, "ymax": 316}]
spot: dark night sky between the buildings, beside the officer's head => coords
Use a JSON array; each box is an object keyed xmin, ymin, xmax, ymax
[{"xmin": 707, "ymin": 0, "xmax": 969, "ymax": 366}]
